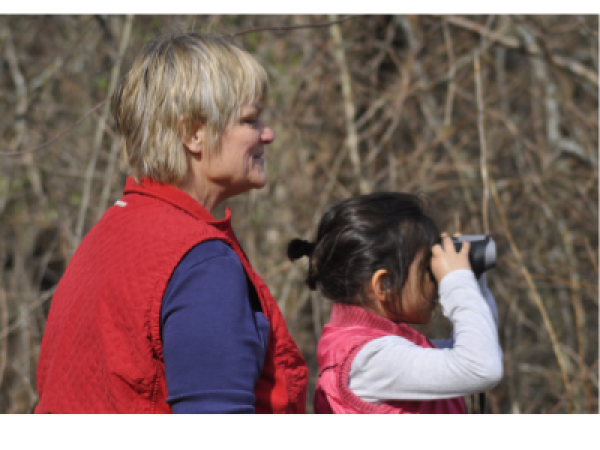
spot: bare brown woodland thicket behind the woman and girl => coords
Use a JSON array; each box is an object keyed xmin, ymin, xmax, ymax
[{"xmin": 0, "ymin": 15, "xmax": 599, "ymax": 413}]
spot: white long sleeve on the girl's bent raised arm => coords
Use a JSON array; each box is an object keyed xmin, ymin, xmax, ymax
[{"xmin": 349, "ymin": 269, "xmax": 503, "ymax": 403}]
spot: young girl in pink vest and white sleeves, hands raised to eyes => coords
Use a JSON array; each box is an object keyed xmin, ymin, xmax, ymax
[{"xmin": 288, "ymin": 192, "xmax": 503, "ymax": 414}]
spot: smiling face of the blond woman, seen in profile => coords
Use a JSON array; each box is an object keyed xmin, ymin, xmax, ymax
[{"xmin": 205, "ymin": 103, "xmax": 274, "ymax": 199}]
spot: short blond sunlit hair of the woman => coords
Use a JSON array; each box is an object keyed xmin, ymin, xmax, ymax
[{"xmin": 111, "ymin": 32, "xmax": 268, "ymax": 185}]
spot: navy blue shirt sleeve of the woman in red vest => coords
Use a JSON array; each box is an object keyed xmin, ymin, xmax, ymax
[{"xmin": 161, "ymin": 241, "xmax": 269, "ymax": 414}]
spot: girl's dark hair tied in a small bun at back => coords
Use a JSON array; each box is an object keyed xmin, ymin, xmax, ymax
[{"xmin": 288, "ymin": 192, "xmax": 440, "ymax": 312}]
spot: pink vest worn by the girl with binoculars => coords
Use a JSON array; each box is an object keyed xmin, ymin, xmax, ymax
[{"xmin": 314, "ymin": 303, "xmax": 466, "ymax": 414}]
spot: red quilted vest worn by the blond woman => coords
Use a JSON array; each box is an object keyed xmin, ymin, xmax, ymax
[{"xmin": 35, "ymin": 178, "xmax": 307, "ymax": 413}]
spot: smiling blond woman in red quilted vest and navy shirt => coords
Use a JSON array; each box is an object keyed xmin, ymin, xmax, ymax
[{"xmin": 35, "ymin": 33, "xmax": 307, "ymax": 413}]
